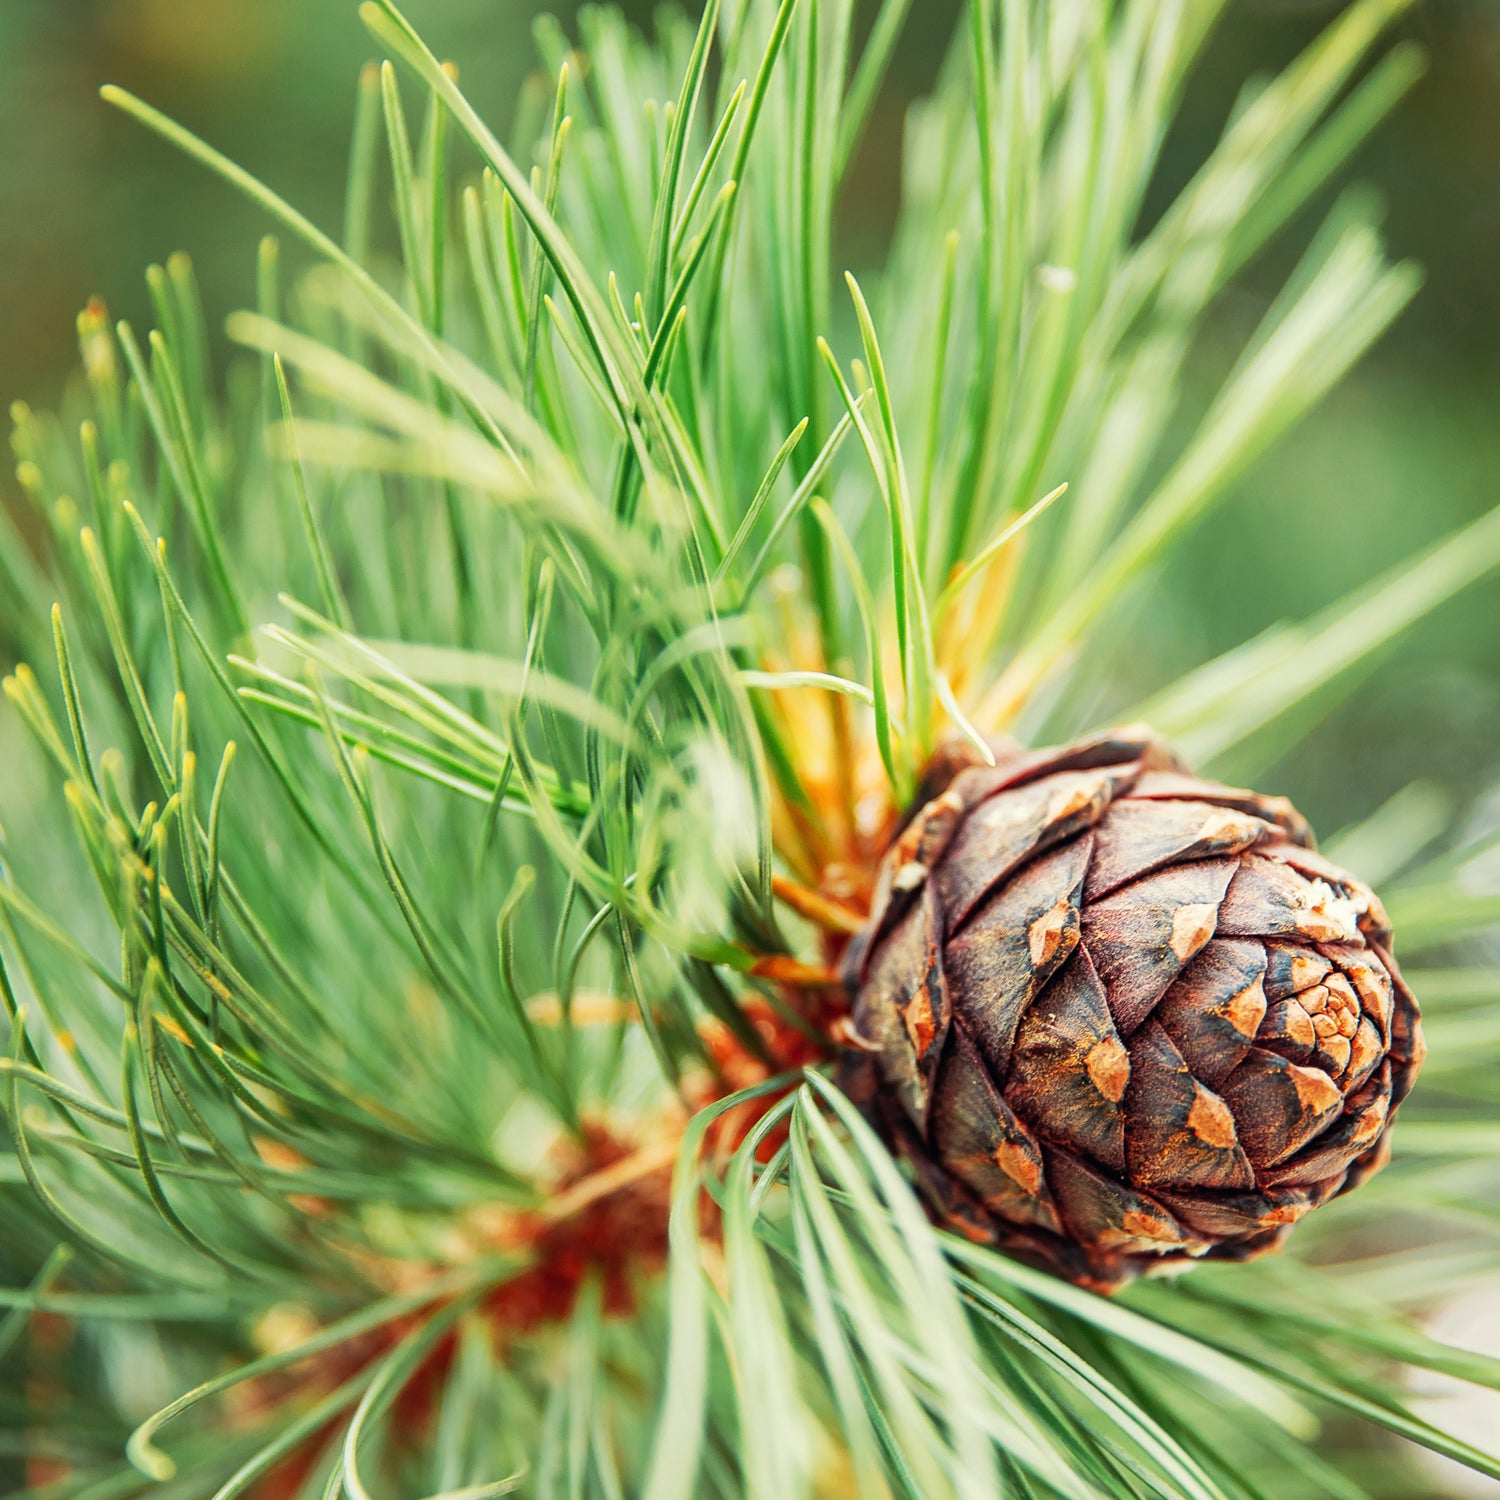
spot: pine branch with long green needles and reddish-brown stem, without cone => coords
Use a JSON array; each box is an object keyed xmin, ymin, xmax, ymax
[{"xmin": 0, "ymin": 0, "xmax": 1500, "ymax": 1500}]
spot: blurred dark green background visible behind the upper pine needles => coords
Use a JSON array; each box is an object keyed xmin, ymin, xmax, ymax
[{"xmin": 0, "ymin": 0, "xmax": 1500, "ymax": 831}]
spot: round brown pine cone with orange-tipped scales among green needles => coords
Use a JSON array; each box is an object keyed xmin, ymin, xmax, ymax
[{"xmin": 845, "ymin": 728, "xmax": 1424, "ymax": 1289}]
